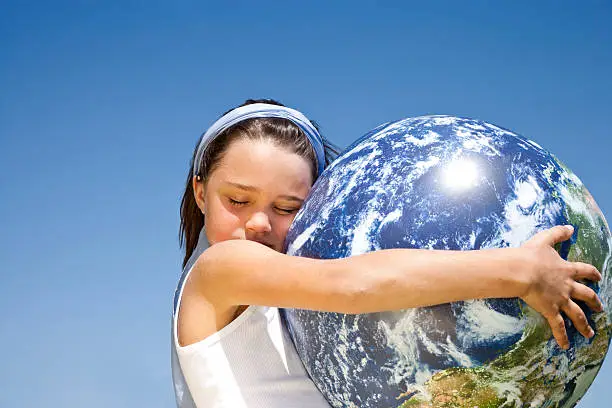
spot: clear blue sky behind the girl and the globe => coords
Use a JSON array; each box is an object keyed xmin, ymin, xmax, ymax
[{"xmin": 0, "ymin": 0, "xmax": 612, "ymax": 408}]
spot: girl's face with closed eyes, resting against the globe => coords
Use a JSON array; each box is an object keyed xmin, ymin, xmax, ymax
[{"xmin": 194, "ymin": 140, "xmax": 313, "ymax": 252}]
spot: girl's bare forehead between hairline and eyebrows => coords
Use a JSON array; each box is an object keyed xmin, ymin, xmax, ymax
[{"xmin": 210, "ymin": 139, "xmax": 313, "ymax": 193}]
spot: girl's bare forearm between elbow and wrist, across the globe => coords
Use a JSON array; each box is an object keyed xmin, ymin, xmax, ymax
[{"xmin": 328, "ymin": 249, "xmax": 529, "ymax": 313}]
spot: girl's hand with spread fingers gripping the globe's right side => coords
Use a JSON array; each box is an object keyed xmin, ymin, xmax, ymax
[{"xmin": 521, "ymin": 226, "xmax": 603, "ymax": 350}]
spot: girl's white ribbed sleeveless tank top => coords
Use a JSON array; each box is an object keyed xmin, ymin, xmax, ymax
[{"xmin": 172, "ymin": 233, "xmax": 329, "ymax": 408}]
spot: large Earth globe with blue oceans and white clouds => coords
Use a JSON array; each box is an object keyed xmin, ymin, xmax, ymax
[{"xmin": 281, "ymin": 116, "xmax": 612, "ymax": 408}]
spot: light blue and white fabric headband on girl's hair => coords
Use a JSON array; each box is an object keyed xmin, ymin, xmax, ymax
[{"xmin": 193, "ymin": 103, "xmax": 325, "ymax": 175}]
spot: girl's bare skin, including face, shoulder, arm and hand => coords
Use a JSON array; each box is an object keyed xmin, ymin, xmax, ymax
[{"xmin": 178, "ymin": 139, "xmax": 603, "ymax": 349}]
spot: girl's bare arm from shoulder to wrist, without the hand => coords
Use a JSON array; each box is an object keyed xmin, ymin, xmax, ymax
[{"xmin": 200, "ymin": 241, "xmax": 528, "ymax": 314}]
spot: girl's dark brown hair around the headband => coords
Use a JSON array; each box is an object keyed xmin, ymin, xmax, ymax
[{"xmin": 179, "ymin": 99, "xmax": 339, "ymax": 267}]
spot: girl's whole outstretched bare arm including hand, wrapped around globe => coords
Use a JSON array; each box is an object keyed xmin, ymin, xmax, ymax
[{"xmin": 190, "ymin": 227, "xmax": 601, "ymax": 346}]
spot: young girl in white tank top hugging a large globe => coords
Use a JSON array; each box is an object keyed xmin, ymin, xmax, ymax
[{"xmin": 172, "ymin": 100, "xmax": 602, "ymax": 408}]
